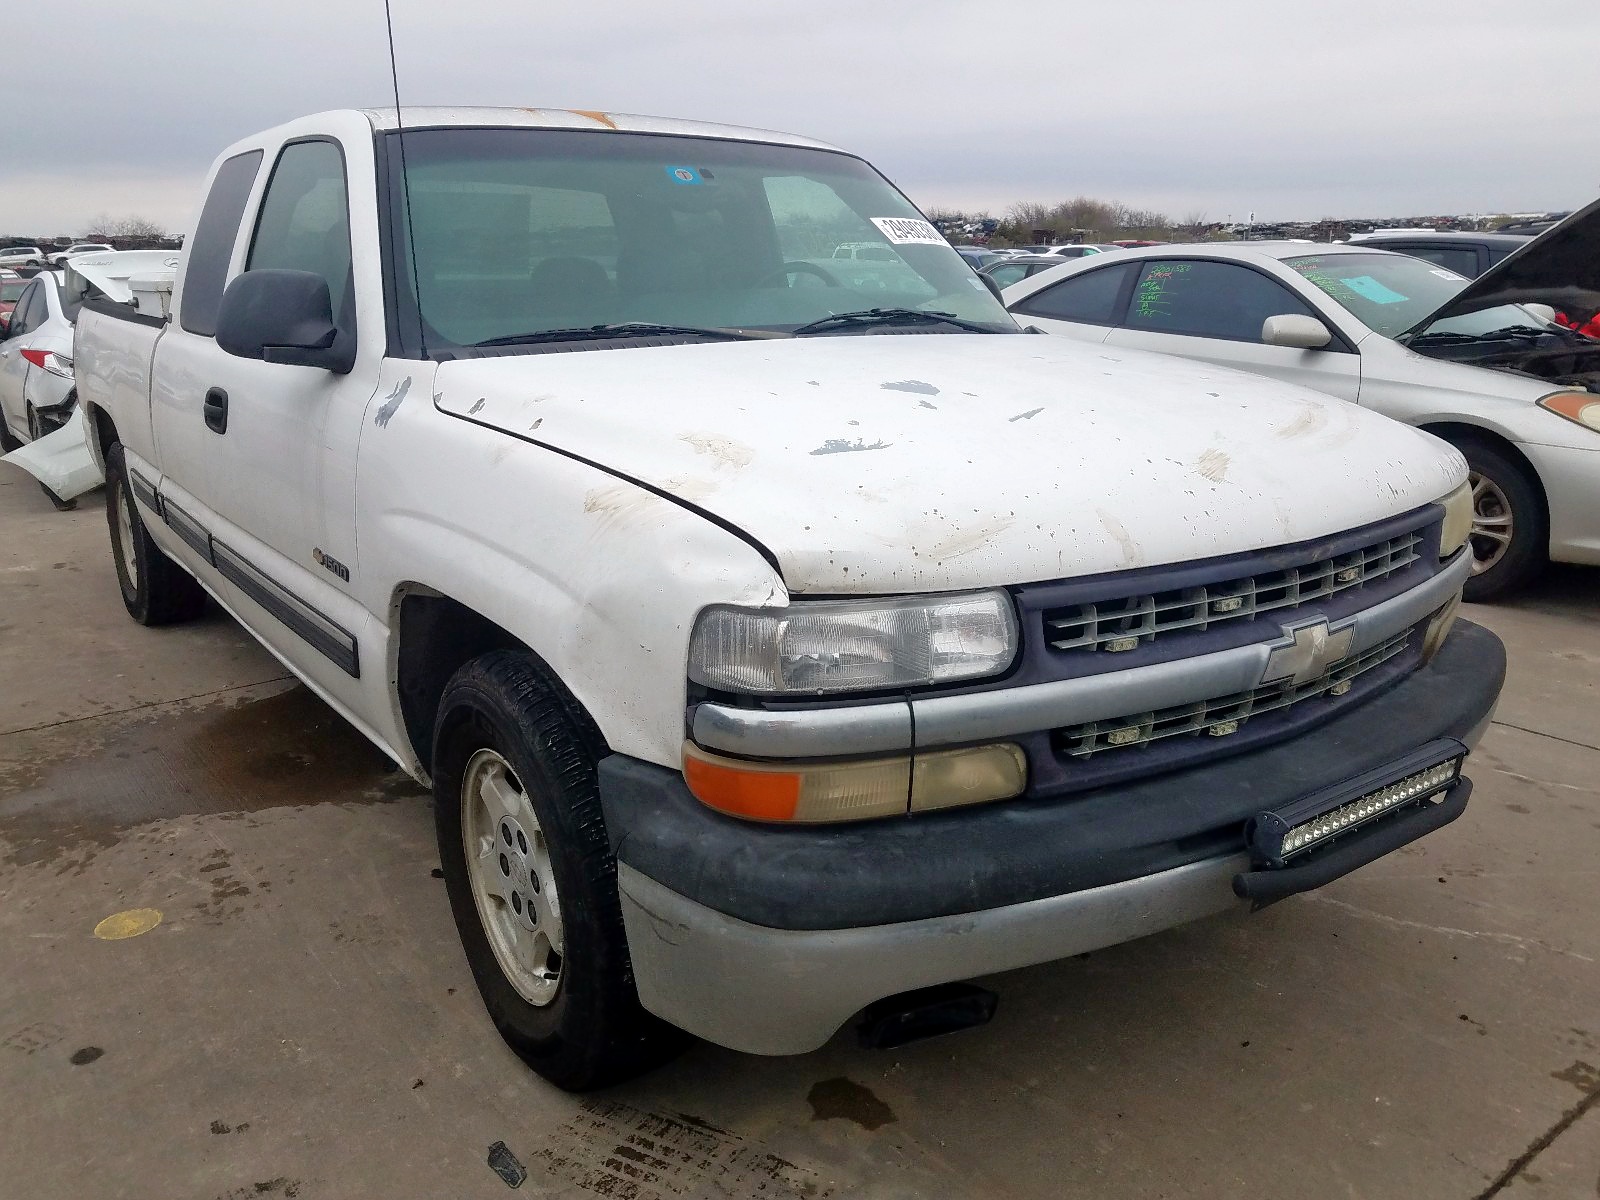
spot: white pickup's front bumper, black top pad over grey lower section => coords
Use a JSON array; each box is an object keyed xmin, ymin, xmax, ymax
[{"xmin": 600, "ymin": 621, "xmax": 1506, "ymax": 1054}]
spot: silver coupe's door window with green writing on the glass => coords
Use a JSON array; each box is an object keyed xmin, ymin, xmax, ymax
[{"xmin": 1123, "ymin": 259, "xmax": 1317, "ymax": 342}]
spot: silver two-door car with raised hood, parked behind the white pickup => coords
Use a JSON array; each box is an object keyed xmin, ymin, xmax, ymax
[{"xmin": 1003, "ymin": 224, "xmax": 1600, "ymax": 600}]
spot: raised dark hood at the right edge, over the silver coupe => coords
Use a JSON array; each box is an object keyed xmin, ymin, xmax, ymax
[{"xmin": 1400, "ymin": 200, "xmax": 1600, "ymax": 338}]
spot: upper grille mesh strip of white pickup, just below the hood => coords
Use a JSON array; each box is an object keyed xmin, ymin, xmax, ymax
[{"xmin": 1045, "ymin": 530, "xmax": 1422, "ymax": 651}]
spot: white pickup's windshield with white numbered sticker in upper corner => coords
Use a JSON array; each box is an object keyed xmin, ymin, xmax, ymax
[{"xmin": 387, "ymin": 128, "xmax": 1016, "ymax": 352}]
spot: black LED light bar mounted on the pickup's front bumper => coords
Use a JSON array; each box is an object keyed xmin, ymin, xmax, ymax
[{"xmin": 1250, "ymin": 738, "xmax": 1467, "ymax": 867}]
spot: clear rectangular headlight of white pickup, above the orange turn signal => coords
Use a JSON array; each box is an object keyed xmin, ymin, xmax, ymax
[{"xmin": 690, "ymin": 592, "xmax": 1016, "ymax": 694}]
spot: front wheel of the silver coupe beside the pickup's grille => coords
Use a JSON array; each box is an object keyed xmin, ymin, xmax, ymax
[{"xmin": 1456, "ymin": 437, "xmax": 1550, "ymax": 603}]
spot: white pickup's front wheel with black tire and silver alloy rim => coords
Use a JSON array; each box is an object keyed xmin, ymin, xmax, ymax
[{"xmin": 434, "ymin": 651, "xmax": 683, "ymax": 1091}]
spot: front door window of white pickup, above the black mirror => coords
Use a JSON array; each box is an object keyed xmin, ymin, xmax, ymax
[{"xmin": 245, "ymin": 141, "xmax": 355, "ymax": 330}]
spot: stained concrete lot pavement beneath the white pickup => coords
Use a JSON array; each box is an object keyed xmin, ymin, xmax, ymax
[{"xmin": 0, "ymin": 454, "xmax": 1600, "ymax": 1200}]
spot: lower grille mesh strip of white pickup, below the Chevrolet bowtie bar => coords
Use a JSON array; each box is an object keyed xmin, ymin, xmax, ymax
[{"xmin": 1051, "ymin": 629, "xmax": 1411, "ymax": 760}]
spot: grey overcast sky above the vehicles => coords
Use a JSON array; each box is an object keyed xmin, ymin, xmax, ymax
[{"xmin": 0, "ymin": 0, "xmax": 1600, "ymax": 235}]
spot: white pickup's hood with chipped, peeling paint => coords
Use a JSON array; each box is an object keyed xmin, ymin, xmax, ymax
[{"xmin": 434, "ymin": 334, "xmax": 1466, "ymax": 594}]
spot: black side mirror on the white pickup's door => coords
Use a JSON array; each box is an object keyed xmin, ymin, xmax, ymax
[{"xmin": 216, "ymin": 270, "xmax": 355, "ymax": 374}]
